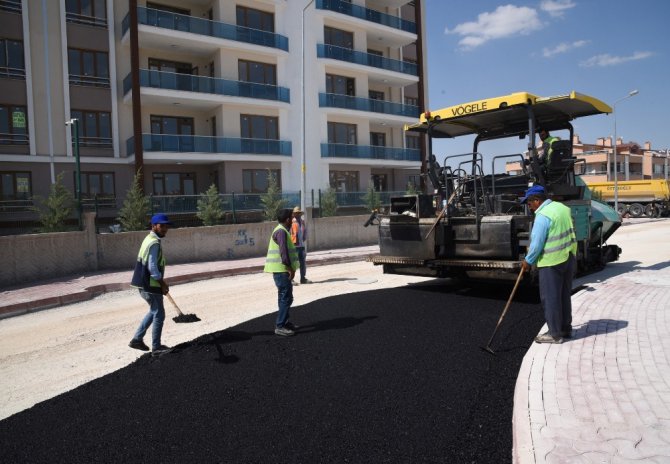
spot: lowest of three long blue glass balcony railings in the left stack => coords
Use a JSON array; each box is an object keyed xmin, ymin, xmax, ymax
[{"xmin": 126, "ymin": 134, "xmax": 292, "ymax": 156}]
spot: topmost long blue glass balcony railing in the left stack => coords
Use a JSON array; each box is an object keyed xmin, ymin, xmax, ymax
[{"xmin": 121, "ymin": 6, "xmax": 288, "ymax": 51}]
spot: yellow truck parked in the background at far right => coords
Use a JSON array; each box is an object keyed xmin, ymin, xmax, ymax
[{"xmin": 586, "ymin": 179, "xmax": 670, "ymax": 218}]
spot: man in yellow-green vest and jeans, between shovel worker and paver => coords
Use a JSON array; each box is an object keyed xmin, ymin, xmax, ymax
[{"xmin": 263, "ymin": 209, "xmax": 298, "ymax": 337}]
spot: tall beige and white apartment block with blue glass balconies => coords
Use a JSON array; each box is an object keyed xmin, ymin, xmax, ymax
[{"xmin": 0, "ymin": 0, "xmax": 427, "ymax": 218}]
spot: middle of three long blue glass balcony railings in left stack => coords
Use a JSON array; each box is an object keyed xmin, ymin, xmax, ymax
[{"xmin": 123, "ymin": 69, "xmax": 291, "ymax": 103}]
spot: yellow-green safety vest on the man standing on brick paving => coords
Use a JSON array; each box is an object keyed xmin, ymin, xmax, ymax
[{"xmin": 536, "ymin": 201, "xmax": 577, "ymax": 267}]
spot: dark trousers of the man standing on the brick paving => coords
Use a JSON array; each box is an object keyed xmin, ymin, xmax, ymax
[{"xmin": 538, "ymin": 255, "xmax": 577, "ymax": 337}]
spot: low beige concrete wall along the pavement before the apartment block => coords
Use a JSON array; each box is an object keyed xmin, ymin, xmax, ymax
[{"xmin": 0, "ymin": 213, "xmax": 377, "ymax": 288}]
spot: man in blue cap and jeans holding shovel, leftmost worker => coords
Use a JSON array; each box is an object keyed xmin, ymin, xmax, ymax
[{"xmin": 128, "ymin": 214, "xmax": 172, "ymax": 355}]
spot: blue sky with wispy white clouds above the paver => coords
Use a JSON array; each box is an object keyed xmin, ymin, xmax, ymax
[{"xmin": 424, "ymin": 0, "xmax": 670, "ymax": 171}]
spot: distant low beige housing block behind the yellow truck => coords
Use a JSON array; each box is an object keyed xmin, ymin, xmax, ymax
[{"xmin": 505, "ymin": 134, "xmax": 670, "ymax": 183}]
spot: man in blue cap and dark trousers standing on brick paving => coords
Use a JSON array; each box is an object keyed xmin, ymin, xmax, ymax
[{"xmin": 521, "ymin": 185, "xmax": 577, "ymax": 343}]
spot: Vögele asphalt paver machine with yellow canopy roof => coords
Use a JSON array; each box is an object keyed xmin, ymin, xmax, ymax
[{"xmin": 366, "ymin": 92, "xmax": 621, "ymax": 280}]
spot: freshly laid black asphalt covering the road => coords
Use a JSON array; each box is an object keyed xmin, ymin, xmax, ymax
[{"xmin": 0, "ymin": 281, "xmax": 543, "ymax": 464}]
